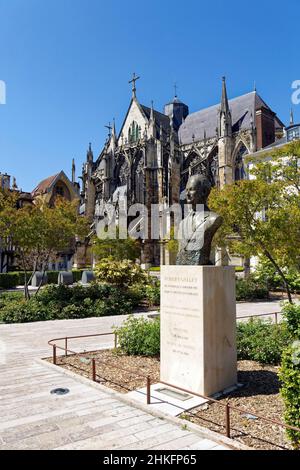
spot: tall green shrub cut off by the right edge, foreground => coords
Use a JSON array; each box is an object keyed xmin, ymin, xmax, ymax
[{"xmin": 279, "ymin": 341, "xmax": 300, "ymax": 450}]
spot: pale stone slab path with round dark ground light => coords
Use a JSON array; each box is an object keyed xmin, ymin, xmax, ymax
[{"xmin": 0, "ymin": 316, "xmax": 237, "ymax": 450}]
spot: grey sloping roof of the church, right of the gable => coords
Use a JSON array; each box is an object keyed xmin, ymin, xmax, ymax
[{"xmin": 179, "ymin": 91, "xmax": 283, "ymax": 144}]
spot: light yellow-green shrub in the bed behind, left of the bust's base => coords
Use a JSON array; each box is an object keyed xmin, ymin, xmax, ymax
[{"xmin": 95, "ymin": 258, "xmax": 148, "ymax": 287}]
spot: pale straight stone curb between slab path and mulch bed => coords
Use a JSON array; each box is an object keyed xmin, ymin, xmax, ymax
[{"xmin": 35, "ymin": 359, "xmax": 253, "ymax": 450}]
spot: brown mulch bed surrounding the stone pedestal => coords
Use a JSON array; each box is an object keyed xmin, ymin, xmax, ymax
[{"xmin": 49, "ymin": 349, "xmax": 291, "ymax": 450}]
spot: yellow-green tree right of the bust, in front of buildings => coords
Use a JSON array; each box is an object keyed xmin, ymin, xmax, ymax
[{"xmin": 210, "ymin": 143, "xmax": 300, "ymax": 303}]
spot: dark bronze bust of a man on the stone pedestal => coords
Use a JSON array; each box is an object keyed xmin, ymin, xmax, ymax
[{"xmin": 176, "ymin": 175, "xmax": 223, "ymax": 266}]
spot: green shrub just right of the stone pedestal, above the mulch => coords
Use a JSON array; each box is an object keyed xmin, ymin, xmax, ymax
[{"xmin": 237, "ymin": 318, "xmax": 291, "ymax": 364}]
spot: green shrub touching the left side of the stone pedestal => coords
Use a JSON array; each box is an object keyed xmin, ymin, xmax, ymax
[{"xmin": 115, "ymin": 316, "xmax": 160, "ymax": 356}]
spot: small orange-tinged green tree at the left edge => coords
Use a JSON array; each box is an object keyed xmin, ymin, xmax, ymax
[{"xmin": 1, "ymin": 198, "xmax": 88, "ymax": 299}]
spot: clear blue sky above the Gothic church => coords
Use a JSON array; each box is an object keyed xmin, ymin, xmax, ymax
[{"xmin": 0, "ymin": 0, "xmax": 300, "ymax": 191}]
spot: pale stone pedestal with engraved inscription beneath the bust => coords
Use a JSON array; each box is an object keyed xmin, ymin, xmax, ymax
[{"xmin": 160, "ymin": 266, "xmax": 237, "ymax": 396}]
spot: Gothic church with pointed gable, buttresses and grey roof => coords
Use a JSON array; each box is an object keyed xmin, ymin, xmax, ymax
[{"xmin": 78, "ymin": 76, "xmax": 284, "ymax": 266}]
